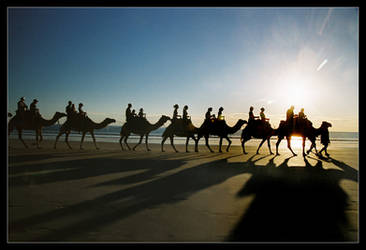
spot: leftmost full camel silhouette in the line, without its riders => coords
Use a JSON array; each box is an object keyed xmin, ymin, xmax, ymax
[{"xmin": 8, "ymin": 111, "xmax": 66, "ymax": 148}]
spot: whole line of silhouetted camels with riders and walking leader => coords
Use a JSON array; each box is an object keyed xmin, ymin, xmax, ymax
[{"xmin": 8, "ymin": 97, "xmax": 332, "ymax": 156}]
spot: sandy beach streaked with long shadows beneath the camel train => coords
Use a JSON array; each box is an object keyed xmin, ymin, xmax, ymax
[{"xmin": 8, "ymin": 139, "xmax": 359, "ymax": 243}]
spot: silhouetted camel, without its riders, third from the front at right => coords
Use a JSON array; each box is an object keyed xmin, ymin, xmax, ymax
[{"xmin": 196, "ymin": 119, "xmax": 247, "ymax": 153}]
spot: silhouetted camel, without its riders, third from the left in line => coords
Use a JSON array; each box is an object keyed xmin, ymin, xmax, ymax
[{"xmin": 119, "ymin": 115, "xmax": 170, "ymax": 151}]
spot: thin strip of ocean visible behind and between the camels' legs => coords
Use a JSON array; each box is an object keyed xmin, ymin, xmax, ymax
[{"xmin": 9, "ymin": 124, "xmax": 359, "ymax": 149}]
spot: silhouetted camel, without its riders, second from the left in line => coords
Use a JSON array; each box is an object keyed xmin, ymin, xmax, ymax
[{"xmin": 54, "ymin": 114, "xmax": 116, "ymax": 150}]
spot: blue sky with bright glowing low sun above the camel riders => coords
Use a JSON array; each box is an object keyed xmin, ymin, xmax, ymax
[{"xmin": 8, "ymin": 7, "xmax": 359, "ymax": 132}]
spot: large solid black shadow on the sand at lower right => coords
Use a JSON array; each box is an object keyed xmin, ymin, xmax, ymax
[{"xmin": 227, "ymin": 157, "xmax": 357, "ymax": 242}]
